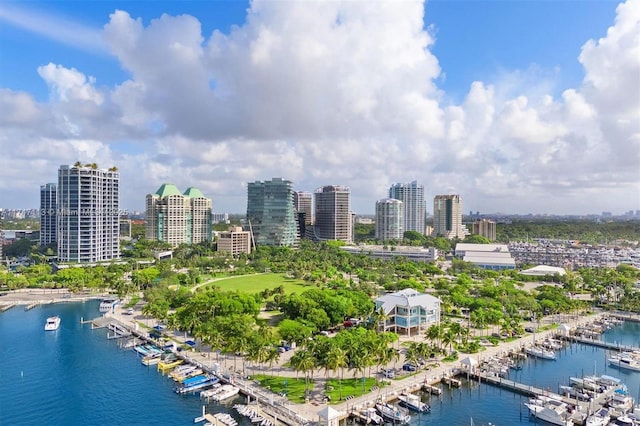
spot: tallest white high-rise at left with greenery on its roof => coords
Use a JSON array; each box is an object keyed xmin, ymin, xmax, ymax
[{"xmin": 56, "ymin": 163, "xmax": 120, "ymax": 263}]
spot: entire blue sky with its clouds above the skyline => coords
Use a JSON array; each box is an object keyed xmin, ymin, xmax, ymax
[{"xmin": 0, "ymin": 0, "xmax": 640, "ymax": 214}]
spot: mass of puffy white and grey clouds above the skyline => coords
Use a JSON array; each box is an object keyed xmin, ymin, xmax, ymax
[{"xmin": 0, "ymin": 0, "xmax": 640, "ymax": 213}]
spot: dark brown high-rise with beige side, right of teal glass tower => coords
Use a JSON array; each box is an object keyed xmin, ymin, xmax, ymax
[{"xmin": 313, "ymin": 185, "xmax": 354, "ymax": 243}]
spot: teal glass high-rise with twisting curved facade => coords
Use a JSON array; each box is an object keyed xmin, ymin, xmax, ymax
[{"xmin": 247, "ymin": 178, "xmax": 298, "ymax": 246}]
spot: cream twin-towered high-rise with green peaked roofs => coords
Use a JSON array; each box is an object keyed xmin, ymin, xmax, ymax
[{"xmin": 145, "ymin": 183, "xmax": 211, "ymax": 247}]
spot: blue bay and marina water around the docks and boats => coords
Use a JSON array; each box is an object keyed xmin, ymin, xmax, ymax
[{"xmin": 0, "ymin": 302, "xmax": 640, "ymax": 426}]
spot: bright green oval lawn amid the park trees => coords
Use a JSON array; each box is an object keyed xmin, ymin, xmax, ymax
[{"xmin": 201, "ymin": 274, "xmax": 308, "ymax": 294}]
